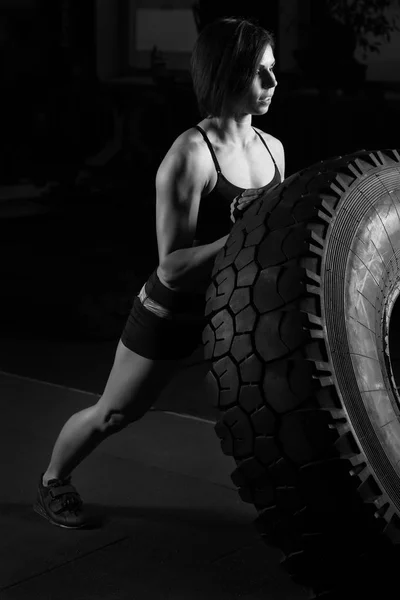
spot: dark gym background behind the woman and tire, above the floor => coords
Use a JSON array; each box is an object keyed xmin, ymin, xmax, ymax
[{"xmin": 0, "ymin": 0, "xmax": 400, "ymax": 355}]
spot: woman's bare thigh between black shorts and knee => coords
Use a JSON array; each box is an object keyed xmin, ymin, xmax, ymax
[{"xmin": 98, "ymin": 341, "xmax": 182, "ymax": 418}]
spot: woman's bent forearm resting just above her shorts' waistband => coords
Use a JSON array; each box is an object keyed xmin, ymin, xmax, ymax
[{"xmin": 157, "ymin": 235, "xmax": 229, "ymax": 291}]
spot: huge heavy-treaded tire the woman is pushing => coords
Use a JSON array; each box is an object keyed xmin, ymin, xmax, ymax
[{"xmin": 203, "ymin": 150, "xmax": 400, "ymax": 598}]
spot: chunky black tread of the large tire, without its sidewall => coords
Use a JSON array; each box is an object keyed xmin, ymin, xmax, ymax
[{"xmin": 203, "ymin": 150, "xmax": 400, "ymax": 600}]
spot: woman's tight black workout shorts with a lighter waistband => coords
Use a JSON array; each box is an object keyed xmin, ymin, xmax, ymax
[{"xmin": 121, "ymin": 271, "xmax": 207, "ymax": 360}]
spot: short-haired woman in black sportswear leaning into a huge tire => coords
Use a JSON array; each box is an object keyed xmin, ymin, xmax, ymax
[{"xmin": 34, "ymin": 18, "xmax": 284, "ymax": 528}]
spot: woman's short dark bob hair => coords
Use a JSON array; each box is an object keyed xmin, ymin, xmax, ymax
[{"xmin": 190, "ymin": 17, "xmax": 275, "ymax": 118}]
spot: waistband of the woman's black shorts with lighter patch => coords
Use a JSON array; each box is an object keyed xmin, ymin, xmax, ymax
[{"xmin": 145, "ymin": 270, "xmax": 205, "ymax": 312}]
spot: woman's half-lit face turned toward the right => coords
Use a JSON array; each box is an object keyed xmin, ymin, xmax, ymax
[{"xmin": 233, "ymin": 45, "xmax": 277, "ymax": 115}]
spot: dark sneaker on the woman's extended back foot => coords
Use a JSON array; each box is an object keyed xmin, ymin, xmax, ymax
[{"xmin": 33, "ymin": 475, "xmax": 88, "ymax": 529}]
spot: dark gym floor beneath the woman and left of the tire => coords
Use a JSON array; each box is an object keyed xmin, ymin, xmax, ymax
[{"xmin": 0, "ymin": 328, "xmax": 307, "ymax": 600}]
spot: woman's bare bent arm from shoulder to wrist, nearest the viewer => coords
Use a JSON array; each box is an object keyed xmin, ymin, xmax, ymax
[{"xmin": 156, "ymin": 145, "xmax": 228, "ymax": 291}]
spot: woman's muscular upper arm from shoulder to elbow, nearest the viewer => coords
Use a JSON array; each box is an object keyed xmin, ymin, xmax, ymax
[{"xmin": 156, "ymin": 144, "xmax": 207, "ymax": 265}]
